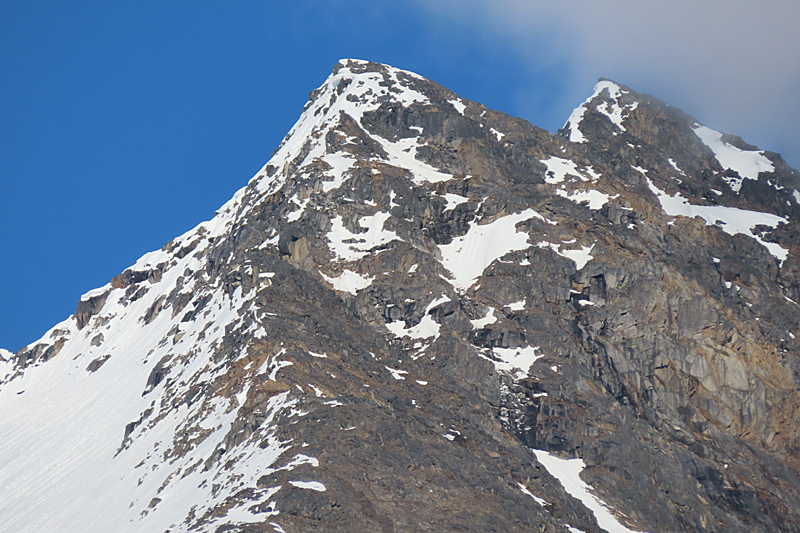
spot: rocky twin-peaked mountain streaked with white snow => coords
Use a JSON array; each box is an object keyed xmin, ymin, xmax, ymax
[{"xmin": 0, "ymin": 60, "xmax": 800, "ymax": 533}]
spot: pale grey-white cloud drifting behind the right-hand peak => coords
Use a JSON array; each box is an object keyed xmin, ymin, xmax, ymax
[{"xmin": 417, "ymin": 0, "xmax": 800, "ymax": 166}]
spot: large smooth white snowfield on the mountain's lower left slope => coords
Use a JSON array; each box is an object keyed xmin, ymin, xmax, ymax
[{"xmin": 0, "ymin": 268, "xmax": 304, "ymax": 532}]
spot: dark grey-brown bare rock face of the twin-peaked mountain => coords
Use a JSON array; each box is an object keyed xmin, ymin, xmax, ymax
[{"xmin": 6, "ymin": 62, "xmax": 800, "ymax": 533}]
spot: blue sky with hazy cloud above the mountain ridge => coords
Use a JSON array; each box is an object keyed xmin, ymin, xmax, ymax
[{"xmin": 0, "ymin": 0, "xmax": 800, "ymax": 351}]
